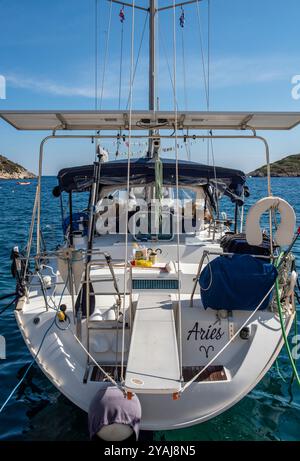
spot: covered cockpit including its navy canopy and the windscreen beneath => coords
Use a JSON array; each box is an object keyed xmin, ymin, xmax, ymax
[{"xmin": 54, "ymin": 158, "xmax": 246, "ymax": 244}]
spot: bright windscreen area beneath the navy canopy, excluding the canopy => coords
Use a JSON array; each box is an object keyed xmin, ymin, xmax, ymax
[{"xmin": 95, "ymin": 184, "xmax": 207, "ymax": 241}]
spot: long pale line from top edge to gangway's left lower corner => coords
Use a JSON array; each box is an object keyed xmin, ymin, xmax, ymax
[{"xmin": 121, "ymin": 0, "xmax": 135, "ymax": 382}]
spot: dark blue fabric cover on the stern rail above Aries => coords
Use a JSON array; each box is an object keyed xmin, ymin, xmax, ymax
[{"xmin": 199, "ymin": 254, "xmax": 278, "ymax": 311}]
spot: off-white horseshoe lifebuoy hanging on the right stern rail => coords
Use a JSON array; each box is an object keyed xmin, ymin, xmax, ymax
[{"xmin": 246, "ymin": 197, "xmax": 296, "ymax": 246}]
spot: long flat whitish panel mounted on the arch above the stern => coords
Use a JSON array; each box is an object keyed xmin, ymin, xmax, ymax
[{"xmin": 0, "ymin": 110, "xmax": 300, "ymax": 132}]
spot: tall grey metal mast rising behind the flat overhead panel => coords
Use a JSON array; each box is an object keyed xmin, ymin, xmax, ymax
[{"xmin": 147, "ymin": 0, "xmax": 157, "ymax": 157}]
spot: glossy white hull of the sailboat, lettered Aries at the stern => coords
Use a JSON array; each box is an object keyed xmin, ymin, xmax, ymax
[{"xmin": 16, "ymin": 256, "xmax": 293, "ymax": 430}]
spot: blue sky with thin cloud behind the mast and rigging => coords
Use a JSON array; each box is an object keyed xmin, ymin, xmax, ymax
[{"xmin": 0, "ymin": 0, "xmax": 300, "ymax": 174}]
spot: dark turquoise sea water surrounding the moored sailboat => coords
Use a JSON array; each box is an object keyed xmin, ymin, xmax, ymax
[{"xmin": 0, "ymin": 177, "xmax": 300, "ymax": 441}]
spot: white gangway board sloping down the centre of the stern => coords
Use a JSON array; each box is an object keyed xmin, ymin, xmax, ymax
[{"xmin": 125, "ymin": 294, "xmax": 180, "ymax": 394}]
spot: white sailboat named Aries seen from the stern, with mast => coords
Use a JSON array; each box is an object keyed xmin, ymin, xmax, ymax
[{"xmin": 0, "ymin": 0, "xmax": 300, "ymax": 440}]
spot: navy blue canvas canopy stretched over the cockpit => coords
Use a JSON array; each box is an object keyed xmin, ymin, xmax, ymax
[{"xmin": 56, "ymin": 158, "xmax": 246, "ymax": 203}]
